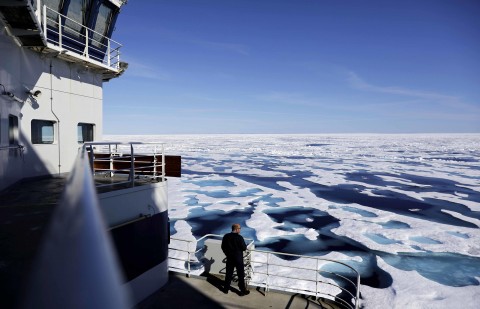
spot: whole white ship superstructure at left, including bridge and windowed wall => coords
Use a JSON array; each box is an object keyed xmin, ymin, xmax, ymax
[{"xmin": 0, "ymin": 0, "xmax": 126, "ymax": 190}]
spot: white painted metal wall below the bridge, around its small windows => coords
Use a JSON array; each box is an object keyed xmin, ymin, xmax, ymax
[{"xmin": 0, "ymin": 28, "xmax": 103, "ymax": 190}]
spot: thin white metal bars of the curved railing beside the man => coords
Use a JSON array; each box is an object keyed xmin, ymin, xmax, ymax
[{"xmin": 169, "ymin": 234, "xmax": 360, "ymax": 309}]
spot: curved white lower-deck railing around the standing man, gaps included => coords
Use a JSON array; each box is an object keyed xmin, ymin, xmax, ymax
[{"xmin": 169, "ymin": 234, "xmax": 360, "ymax": 309}]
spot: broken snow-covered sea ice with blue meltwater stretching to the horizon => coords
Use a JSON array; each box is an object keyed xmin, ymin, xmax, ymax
[{"xmin": 107, "ymin": 134, "xmax": 480, "ymax": 309}]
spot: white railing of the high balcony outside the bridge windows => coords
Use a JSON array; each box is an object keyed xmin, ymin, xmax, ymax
[{"xmin": 42, "ymin": 5, "xmax": 122, "ymax": 72}]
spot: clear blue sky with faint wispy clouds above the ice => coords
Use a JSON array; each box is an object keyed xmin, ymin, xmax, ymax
[{"xmin": 104, "ymin": 0, "xmax": 480, "ymax": 135}]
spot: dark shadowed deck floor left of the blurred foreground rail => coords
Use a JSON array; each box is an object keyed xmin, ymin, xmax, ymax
[{"xmin": 0, "ymin": 175, "xmax": 66, "ymax": 308}]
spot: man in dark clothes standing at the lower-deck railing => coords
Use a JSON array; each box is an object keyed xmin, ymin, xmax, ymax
[{"xmin": 222, "ymin": 223, "xmax": 250, "ymax": 296}]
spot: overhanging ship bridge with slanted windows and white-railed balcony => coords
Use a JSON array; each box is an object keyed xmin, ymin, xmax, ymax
[{"xmin": 0, "ymin": 0, "xmax": 127, "ymax": 80}]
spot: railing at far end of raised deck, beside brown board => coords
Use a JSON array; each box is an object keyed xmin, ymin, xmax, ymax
[{"xmin": 83, "ymin": 142, "xmax": 165, "ymax": 188}]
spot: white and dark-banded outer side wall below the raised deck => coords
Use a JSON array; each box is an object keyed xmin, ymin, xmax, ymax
[{"xmin": 99, "ymin": 181, "xmax": 170, "ymax": 303}]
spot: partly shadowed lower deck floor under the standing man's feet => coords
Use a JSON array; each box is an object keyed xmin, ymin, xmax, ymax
[{"xmin": 139, "ymin": 272, "xmax": 338, "ymax": 309}]
